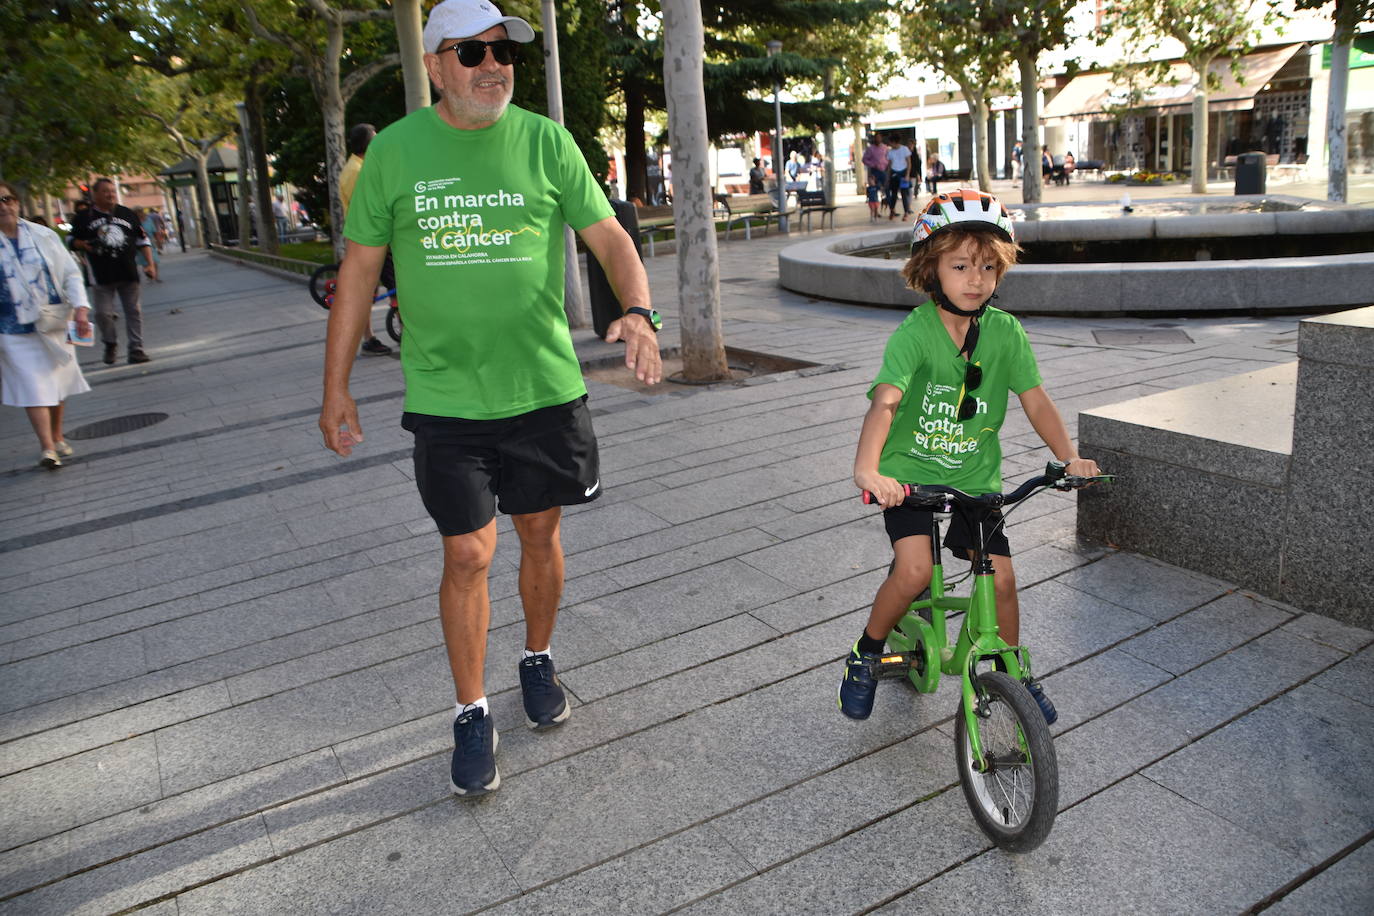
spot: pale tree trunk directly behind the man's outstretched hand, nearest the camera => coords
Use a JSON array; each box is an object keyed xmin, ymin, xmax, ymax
[{"xmin": 662, "ymin": 0, "xmax": 730, "ymax": 382}]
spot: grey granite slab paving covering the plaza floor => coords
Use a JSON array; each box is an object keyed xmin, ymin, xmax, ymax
[{"xmin": 0, "ymin": 177, "xmax": 1374, "ymax": 916}]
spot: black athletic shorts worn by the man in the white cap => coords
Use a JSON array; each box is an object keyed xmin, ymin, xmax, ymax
[{"xmin": 401, "ymin": 396, "xmax": 600, "ymax": 537}]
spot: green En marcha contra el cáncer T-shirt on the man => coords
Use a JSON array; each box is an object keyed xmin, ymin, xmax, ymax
[{"xmin": 345, "ymin": 106, "xmax": 613, "ymax": 420}]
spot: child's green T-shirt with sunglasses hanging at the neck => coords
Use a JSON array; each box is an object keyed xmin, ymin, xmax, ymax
[{"xmin": 868, "ymin": 301, "xmax": 1040, "ymax": 494}]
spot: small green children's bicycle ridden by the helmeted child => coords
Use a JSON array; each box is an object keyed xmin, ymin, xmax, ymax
[{"xmin": 863, "ymin": 463, "xmax": 1113, "ymax": 853}]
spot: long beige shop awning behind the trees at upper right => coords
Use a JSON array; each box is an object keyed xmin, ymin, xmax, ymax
[{"xmin": 1040, "ymin": 43, "xmax": 1303, "ymax": 121}]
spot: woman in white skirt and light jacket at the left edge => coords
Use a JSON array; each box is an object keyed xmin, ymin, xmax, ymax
[{"xmin": 0, "ymin": 181, "xmax": 91, "ymax": 470}]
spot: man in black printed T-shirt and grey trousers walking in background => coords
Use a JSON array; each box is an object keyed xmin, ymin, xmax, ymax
[{"xmin": 71, "ymin": 179, "xmax": 157, "ymax": 365}]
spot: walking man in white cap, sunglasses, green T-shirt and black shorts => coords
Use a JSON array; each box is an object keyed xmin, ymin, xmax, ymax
[{"xmin": 320, "ymin": 0, "xmax": 662, "ymax": 795}]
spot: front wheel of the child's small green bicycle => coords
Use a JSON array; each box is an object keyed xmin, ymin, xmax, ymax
[{"xmin": 954, "ymin": 672, "xmax": 1059, "ymax": 853}]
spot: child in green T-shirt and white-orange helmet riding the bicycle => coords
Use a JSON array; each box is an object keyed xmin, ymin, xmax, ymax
[{"xmin": 840, "ymin": 188, "xmax": 1098, "ymax": 722}]
